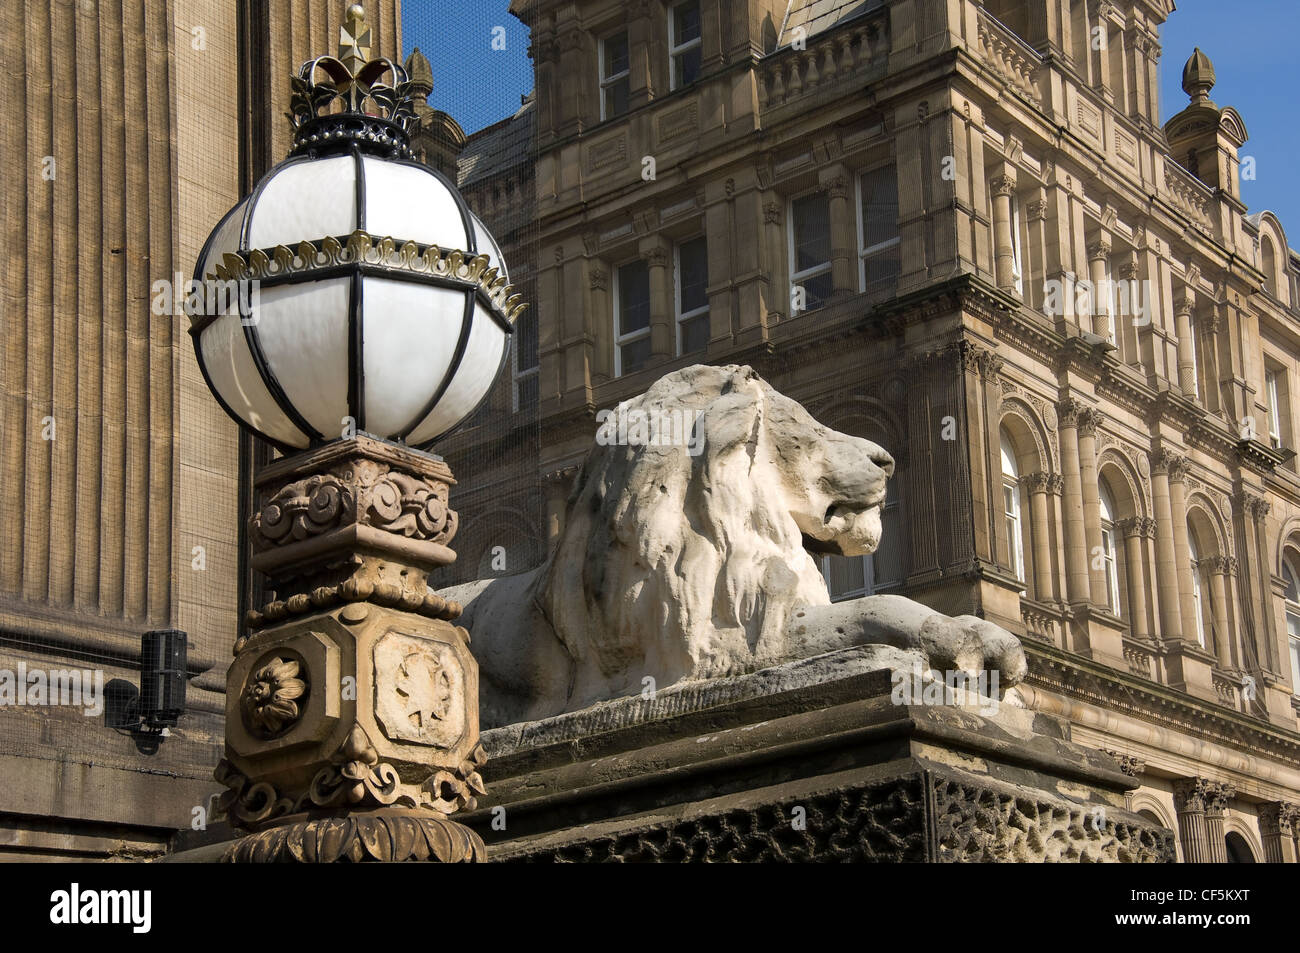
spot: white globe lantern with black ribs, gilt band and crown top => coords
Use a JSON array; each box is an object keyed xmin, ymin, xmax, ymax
[{"xmin": 190, "ymin": 5, "xmax": 524, "ymax": 451}]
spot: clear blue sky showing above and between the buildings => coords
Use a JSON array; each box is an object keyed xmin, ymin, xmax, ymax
[{"xmin": 402, "ymin": 0, "xmax": 1300, "ymax": 234}]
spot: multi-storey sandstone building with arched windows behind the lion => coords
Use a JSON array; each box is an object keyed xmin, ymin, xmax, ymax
[{"xmin": 434, "ymin": 0, "xmax": 1300, "ymax": 861}]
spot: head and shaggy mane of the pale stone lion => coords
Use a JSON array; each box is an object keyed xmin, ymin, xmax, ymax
[{"xmin": 536, "ymin": 365, "xmax": 893, "ymax": 705}]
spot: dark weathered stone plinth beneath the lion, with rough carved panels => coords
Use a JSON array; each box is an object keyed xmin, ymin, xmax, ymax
[{"xmin": 462, "ymin": 646, "xmax": 1174, "ymax": 862}]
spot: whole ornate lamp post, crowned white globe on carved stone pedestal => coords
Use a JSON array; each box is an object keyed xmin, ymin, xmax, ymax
[{"xmin": 191, "ymin": 5, "xmax": 523, "ymax": 861}]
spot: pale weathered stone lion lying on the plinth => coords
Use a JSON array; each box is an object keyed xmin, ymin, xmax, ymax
[{"xmin": 442, "ymin": 365, "xmax": 1026, "ymax": 727}]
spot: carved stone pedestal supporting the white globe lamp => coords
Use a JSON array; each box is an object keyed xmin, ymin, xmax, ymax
[{"xmin": 217, "ymin": 436, "xmax": 486, "ymax": 862}]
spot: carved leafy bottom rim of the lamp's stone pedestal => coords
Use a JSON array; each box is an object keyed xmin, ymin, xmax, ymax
[{"xmin": 220, "ymin": 807, "xmax": 488, "ymax": 863}]
